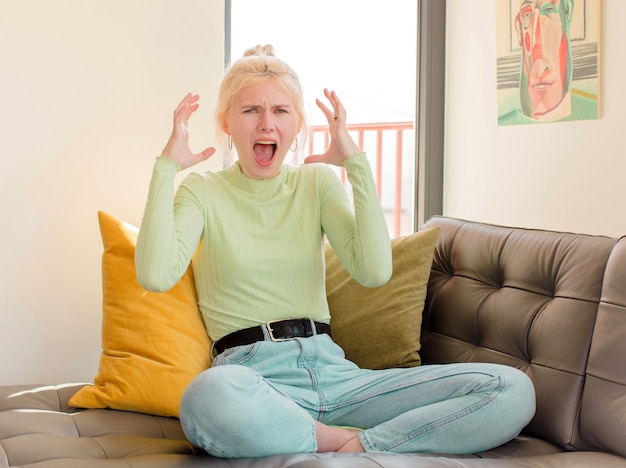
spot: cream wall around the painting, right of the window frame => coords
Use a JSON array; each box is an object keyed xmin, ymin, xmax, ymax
[{"xmin": 444, "ymin": 0, "xmax": 626, "ymax": 236}]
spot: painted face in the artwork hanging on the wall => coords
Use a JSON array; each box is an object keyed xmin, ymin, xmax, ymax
[{"xmin": 515, "ymin": 0, "xmax": 573, "ymax": 118}]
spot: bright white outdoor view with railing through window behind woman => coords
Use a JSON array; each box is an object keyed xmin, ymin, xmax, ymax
[{"xmin": 230, "ymin": 0, "xmax": 417, "ymax": 237}]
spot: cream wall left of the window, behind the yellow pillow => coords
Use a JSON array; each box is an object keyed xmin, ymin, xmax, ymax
[{"xmin": 0, "ymin": 0, "xmax": 224, "ymax": 385}]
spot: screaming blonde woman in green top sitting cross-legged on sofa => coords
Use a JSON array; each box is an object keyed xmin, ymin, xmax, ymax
[{"xmin": 136, "ymin": 46, "xmax": 534, "ymax": 458}]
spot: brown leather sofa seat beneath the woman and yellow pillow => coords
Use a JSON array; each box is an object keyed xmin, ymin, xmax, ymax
[{"xmin": 0, "ymin": 384, "xmax": 626, "ymax": 468}]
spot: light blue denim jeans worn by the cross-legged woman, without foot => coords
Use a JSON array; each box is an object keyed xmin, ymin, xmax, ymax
[{"xmin": 180, "ymin": 335, "xmax": 535, "ymax": 458}]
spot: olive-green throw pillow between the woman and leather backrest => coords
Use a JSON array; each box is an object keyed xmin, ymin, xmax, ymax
[{"xmin": 326, "ymin": 227, "xmax": 439, "ymax": 369}]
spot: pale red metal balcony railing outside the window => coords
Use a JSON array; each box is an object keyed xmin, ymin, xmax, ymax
[{"xmin": 308, "ymin": 122, "xmax": 414, "ymax": 237}]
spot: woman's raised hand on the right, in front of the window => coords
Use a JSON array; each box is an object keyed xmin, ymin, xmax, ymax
[{"xmin": 304, "ymin": 89, "xmax": 361, "ymax": 166}]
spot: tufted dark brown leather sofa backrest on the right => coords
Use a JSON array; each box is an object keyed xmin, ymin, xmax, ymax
[{"xmin": 421, "ymin": 217, "xmax": 626, "ymax": 455}]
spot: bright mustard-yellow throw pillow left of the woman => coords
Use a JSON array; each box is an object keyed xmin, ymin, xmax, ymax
[{"xmin": 70, "ymin": 212, "xmax": 211, "ymax": 416}]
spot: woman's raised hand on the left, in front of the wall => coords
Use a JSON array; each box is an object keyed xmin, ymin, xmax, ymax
[{"xmin": 161, "ymin": 93, "xmax": 215, "ymax": 170}]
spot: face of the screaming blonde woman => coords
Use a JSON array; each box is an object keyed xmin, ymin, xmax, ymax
[{"xmin": 224, "ymin": 79, "xmax": 300, "ymax": 179}]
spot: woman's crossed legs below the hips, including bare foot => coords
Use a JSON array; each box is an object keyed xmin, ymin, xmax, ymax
[{"xmin": 181, "ymin": 364, "xmax": 534, "ymax": 458}]
